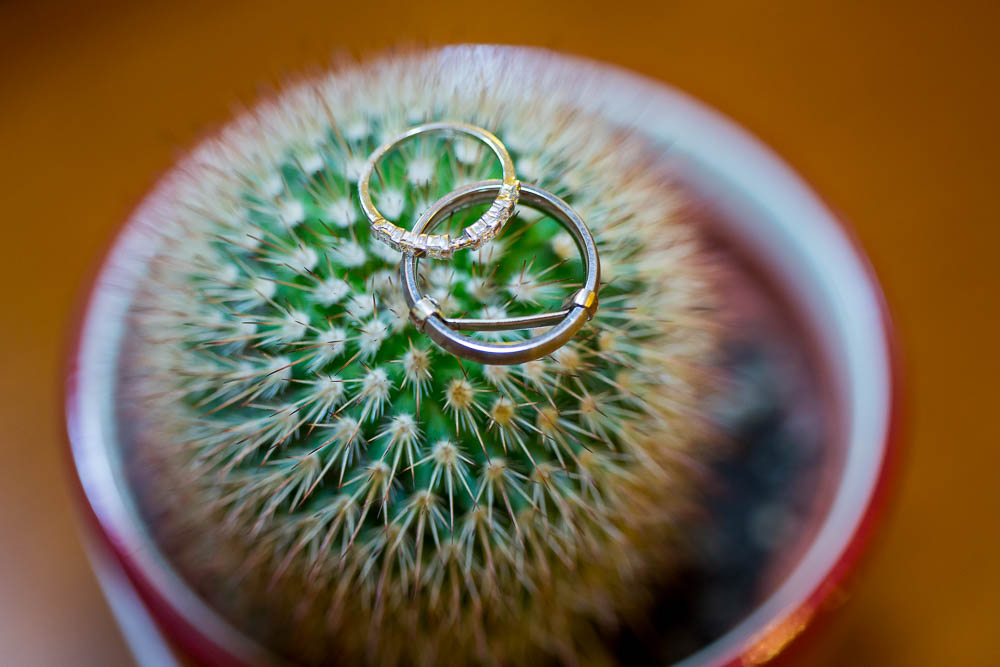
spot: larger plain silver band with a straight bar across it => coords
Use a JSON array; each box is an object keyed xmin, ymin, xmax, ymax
[{"xmin": 399, "ymin": 180, "xmax": 601, "ymax": 365}]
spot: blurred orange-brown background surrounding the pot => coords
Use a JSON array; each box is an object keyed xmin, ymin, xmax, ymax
[{"xmin": 0, "ymin": 0, "xmax": 1000, "ymax": 665}]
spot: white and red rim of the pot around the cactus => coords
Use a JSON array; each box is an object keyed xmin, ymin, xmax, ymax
[{"xmin": 64, "ymin": 46, "xmax": 902, "ymax": 666}]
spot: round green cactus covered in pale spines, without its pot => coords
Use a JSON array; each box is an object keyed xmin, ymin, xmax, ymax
[{"xmin": 128, "ymin": 49, "xmax": 715, "ymax": 664}]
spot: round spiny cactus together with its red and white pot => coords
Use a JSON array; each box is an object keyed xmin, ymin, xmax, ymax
[{"xmin": 68, "ymin": 47, "xmax": 904, "ymax": 664}]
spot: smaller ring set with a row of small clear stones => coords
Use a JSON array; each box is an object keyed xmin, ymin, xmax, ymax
[{"xmin": 358, "ymin": 122, "xmax": 521, "ymax": 259}]
